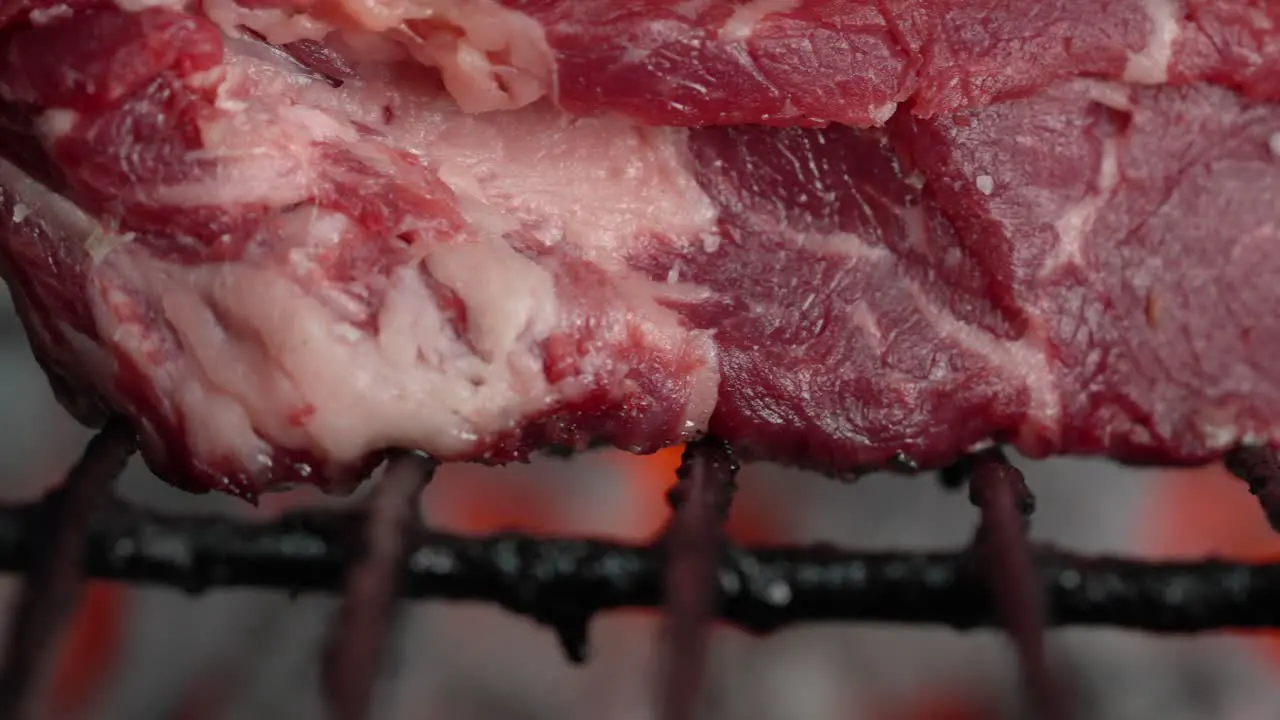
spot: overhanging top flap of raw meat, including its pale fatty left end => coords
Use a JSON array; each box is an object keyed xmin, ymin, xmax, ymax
[{"xmin": 177, "ymin": 0, "xmax": 1280, "ymax": 127}]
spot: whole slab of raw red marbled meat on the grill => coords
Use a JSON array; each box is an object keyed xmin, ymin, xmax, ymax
[{"xmin": 0, "ymin": 0, "xmax": 1280, "ymax": 497}]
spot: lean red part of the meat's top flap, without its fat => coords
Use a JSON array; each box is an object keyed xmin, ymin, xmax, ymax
[{"xmin": 503, "ymin": 0, "xmax": 1280, "ymax": 126}]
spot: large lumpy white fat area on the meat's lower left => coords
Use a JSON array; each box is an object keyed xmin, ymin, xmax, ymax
[{"xmin": 104, "ymin": 249, "xmax": 560, "ymax": 468}]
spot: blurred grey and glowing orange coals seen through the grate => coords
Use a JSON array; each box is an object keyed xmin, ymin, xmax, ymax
[{"xmin": 0, "ymin": 293, "xmax": 1280, "ymax": 720}]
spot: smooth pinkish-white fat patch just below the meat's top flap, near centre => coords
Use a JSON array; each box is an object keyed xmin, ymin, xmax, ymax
[{"xmin": 422, "ymin": 113, "xmax": 721, "ymax": 267}]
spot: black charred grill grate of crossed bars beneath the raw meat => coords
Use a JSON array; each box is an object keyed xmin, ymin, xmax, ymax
[{"xmin": 0, "ymin": 420, "xmax": 1280, "ymax": 720}]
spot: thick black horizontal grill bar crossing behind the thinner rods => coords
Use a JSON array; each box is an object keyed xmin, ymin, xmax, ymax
[{"xmin": 0, "ymin": 484, "xmax": 1280, "ymax": 633}]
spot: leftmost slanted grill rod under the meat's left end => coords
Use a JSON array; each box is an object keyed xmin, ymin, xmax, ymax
[{"xmin": 0, "ymin": 418, "xmax": 137, "ymax": 720}]
